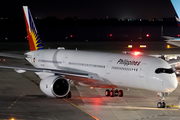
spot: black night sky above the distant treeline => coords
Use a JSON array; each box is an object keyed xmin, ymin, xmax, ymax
[{"xmin": 0, "ymin": 0, "xmax": 176, "ymax": 19}]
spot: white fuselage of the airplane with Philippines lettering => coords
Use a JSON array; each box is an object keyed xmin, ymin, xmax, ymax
[{"xmin": 26, "ymin": 49, "xmax": 178, "ymax": 92}]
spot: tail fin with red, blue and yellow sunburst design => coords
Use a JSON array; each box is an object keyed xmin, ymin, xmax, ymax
[{"xmin": 23, "ymin": 6, "xmax": 43, "ymax": 51}]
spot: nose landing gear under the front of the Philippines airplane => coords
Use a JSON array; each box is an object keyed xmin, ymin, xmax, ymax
[{"xmin": 157, "ymin": 92, "xmax": 169, "ymax": 108}]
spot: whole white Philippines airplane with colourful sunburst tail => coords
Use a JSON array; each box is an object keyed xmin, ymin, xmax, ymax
[{"xmin": 0, "ymin": 6, "xmax": 178, "ymax": 108}]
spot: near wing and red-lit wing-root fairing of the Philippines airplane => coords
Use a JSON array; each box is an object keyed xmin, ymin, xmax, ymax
[{"xmin": 0, "ymin": 65, "xmax": 108, "ymax": 87}]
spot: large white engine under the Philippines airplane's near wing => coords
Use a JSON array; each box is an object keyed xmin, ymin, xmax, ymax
[{"xmin": 40, "ymin": 75, "xmax": 70, "ymax": 97}]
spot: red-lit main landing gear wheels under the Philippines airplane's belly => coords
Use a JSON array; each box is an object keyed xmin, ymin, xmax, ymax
[{"xmin": 105, "ymin": 89, "xmax": 123, "ymax": 97}]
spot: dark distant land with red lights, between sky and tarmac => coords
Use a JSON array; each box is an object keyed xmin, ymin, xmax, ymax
[{"xmin": 0, "ymin": 17, "xmax": 180, "ymax": 42}]
